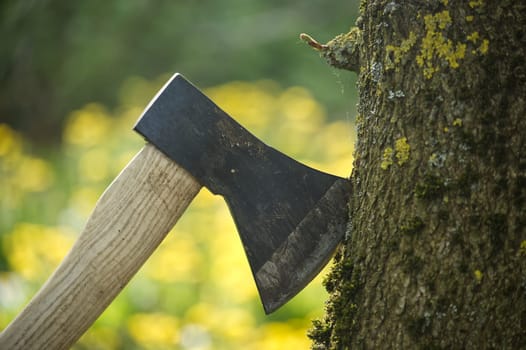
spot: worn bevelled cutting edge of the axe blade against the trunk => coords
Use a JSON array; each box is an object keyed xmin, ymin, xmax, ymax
[{"xmin": 254, "ymin": 179, "xmax": 350, "ymax": 314}]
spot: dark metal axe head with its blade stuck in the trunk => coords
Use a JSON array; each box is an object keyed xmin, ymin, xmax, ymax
[{"xmin": 135, "ymin": 74, "xmax": 350, "ymax": 314}]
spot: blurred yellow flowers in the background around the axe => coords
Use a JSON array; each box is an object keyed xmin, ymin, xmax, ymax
[{"xmin": 0, "ymin": 77, "xmax": 354, "ymax": 350}]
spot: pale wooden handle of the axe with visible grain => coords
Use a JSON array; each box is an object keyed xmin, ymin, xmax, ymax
[{"xmin": 0, "ymin": 145, "xmax": 201, "ymax": 349}]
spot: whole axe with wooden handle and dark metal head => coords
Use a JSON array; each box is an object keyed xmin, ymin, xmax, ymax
[{"xmin": 0, "ymin": 74, "xmax": 350, "ymax": 349}]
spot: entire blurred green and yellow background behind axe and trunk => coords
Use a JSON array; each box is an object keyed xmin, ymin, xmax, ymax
[{"xmin": 0, "ymin": 0, "xmax": 358, "ymax": 349}]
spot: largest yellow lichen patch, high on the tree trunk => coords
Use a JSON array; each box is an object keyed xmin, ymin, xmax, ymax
[{"xmin": 416, "ymin": 10, "xmax": 466, "ymax": 79}]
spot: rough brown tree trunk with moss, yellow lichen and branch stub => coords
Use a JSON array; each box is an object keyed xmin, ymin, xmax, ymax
[{"xmin": 310, "ymin": 0, "xmax": 526, "ymax": 349}]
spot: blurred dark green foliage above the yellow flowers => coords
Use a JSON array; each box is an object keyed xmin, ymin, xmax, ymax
[{"xmin": 0, "ymin": 0, "xmax": 358, "ymax": 144}]
